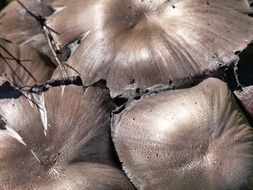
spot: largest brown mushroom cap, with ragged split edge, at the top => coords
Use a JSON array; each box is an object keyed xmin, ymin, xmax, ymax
[{"xmin": 47, "ymin": 0, "xmax": 253, "ymax": 97}]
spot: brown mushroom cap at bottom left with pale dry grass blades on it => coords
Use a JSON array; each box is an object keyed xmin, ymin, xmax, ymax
[{"xmin": 0, "ymin": 80, "xmax": 133, "ymax": 190}]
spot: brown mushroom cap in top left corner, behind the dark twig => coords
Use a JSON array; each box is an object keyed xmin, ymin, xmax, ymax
[{"xmin": 0, "ymin": 0, "xmax": 53, "ymax": 56}]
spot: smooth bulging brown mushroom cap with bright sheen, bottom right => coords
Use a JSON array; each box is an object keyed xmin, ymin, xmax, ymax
[{"xmin": 112, "ymin": 78, "xmax": 253, "ymax": 190}]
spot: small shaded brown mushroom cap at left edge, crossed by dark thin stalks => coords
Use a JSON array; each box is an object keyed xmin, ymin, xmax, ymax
[{"xmin": 0, "ymin": 42, "xmax": 55, "ymax": 87}]
